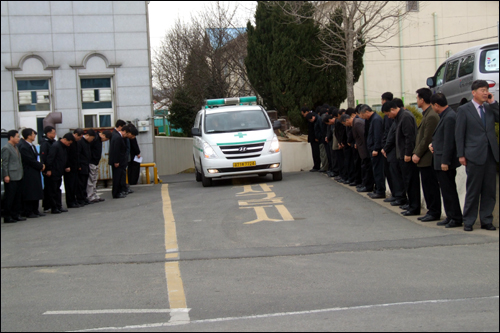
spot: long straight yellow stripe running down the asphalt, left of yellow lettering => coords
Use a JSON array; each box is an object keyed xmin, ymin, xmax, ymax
[{"xmin": 161, "ymin": 184, "xmax": 189, "ymax": 312}]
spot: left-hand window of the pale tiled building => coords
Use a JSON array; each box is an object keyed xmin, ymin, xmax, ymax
[{"xmin": 17, "ymin": 80, "xmax": 50, "ymax": 112}]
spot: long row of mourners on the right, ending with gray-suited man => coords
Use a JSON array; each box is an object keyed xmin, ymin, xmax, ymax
[{"xmin": 301, "ymin": 80, "xmax": 499, "ymax": 231}]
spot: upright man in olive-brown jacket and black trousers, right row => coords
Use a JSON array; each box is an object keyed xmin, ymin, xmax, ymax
[{"xmin": 412, "ymin": 88, "xmax": 441, "ymax": 222}]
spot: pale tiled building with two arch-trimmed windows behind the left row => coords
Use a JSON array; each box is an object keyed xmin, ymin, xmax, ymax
[{"xmin": 1, "ymin": 1, "xmax": 154, "ymax": 162}]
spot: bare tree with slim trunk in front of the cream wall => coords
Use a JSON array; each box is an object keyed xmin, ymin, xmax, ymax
[{"xmin": 276, "ymin": 1, "xmax": 408, "ymax": 107}]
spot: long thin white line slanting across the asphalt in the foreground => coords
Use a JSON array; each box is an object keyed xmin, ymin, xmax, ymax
[{"xmin": 64, "ymin": 296, "xmax": 499, "ymax": 332}]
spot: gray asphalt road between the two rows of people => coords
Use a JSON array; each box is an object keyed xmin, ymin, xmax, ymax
[{"xmin": 1, "ymin": 172, "xmax": 499, "ymax": 332}]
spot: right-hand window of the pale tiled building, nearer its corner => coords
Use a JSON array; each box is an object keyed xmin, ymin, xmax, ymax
[{"xmin": 80, "ymin": 78, "xmax": 113, "ymax": 128}]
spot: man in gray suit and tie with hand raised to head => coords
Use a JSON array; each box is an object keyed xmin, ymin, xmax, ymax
[{"xmin": 455, "ymin": 80, "xmax": 499, "ymax": 231}]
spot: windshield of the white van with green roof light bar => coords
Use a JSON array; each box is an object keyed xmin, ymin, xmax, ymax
[{"xmin": 205, "ymin": 110, "xmax": 271, "ymax": 134}]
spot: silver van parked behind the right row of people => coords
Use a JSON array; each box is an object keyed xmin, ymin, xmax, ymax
[{"xmin": 427, "ymin": 44, "xmax": 499, "ymax": 111}]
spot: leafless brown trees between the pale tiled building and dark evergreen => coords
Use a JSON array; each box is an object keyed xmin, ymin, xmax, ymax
[{"xmin": 153, "ymin": 2, "xmax": 250, "ymax": 109}]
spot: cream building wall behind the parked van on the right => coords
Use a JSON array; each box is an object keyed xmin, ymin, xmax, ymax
[{"xmin": 344, "ymin": 1, "xmax": 499, "ymax": 106}]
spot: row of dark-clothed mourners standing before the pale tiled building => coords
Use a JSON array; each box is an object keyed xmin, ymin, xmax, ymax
[{"xmin": 2, "ymin": 120, "xmax": 141, "ymax": 223}]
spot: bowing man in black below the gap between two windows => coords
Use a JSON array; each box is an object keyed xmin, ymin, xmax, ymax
[{"xmin": 46, "ymin": 133, "xmax": 75, "ymax": 214}]
